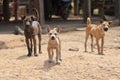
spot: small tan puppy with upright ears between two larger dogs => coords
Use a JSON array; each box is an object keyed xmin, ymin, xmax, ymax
[{"xmin": 47, "ymin": 26, "xmax": 62, "ymax": 64}]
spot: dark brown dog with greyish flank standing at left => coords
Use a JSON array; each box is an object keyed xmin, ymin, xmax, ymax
[{"xmin": 22, "ymin": 8, "xmax": 42, "ymax": 56}]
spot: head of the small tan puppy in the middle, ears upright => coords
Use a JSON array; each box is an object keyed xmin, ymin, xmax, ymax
[{"xmin": 47, "ymin": 26, "xmax": 60, "ymax": 40}]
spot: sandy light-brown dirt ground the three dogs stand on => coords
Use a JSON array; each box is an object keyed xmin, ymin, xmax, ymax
[{"xmin": 0, "ymin": 26, "xmax": 120, "ymax": 80}]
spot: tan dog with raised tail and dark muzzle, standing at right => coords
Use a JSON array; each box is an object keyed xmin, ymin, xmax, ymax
[{"xmin": 85, "ymin": 17, "xmax": 111, "ymax": 55}]
